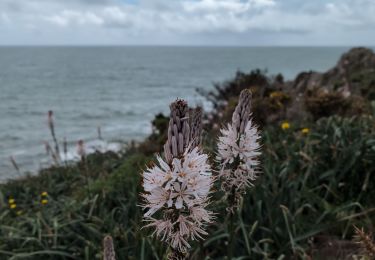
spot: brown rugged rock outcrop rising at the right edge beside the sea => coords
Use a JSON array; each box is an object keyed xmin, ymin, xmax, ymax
[{"xmin": 284, "ymin": 48, "xmax": 375, "ymax": 120}]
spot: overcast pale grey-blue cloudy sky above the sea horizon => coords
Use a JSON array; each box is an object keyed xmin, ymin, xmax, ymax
[{"xmin": 0, "ymin": 0, "xmax": 375, "ymax": 46}]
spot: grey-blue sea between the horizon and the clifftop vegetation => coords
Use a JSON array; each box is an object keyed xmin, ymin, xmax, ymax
[{"xmin": 0, "ymin": 47, "xmax": 358, "ymax": 179}]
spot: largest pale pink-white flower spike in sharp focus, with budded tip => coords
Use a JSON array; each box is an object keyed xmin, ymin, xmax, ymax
[{"xmin": 142, "ymin": 100, "xmax": 214, "ymax": 259}]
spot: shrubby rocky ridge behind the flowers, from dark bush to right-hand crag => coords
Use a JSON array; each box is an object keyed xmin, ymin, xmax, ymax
[{"xmin": 201, "ymin": 48, "xmax": 375, "ymax": 125}]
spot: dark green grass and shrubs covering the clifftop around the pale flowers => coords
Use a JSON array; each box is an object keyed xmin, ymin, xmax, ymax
[{"xmin": 0, "ymin": 48, "xmax": 375, "ymax": 259}]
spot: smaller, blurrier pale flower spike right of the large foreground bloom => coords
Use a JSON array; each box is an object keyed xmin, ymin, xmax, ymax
[{"xmin": 217, "ymin": 89, "xmax": 261, "ymax": 213}]
